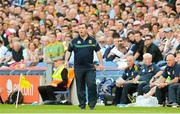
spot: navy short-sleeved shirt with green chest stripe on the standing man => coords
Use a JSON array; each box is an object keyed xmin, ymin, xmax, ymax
[{"xmin": 68, "ymin": 36, "xmax": 101, "ymax": 69}]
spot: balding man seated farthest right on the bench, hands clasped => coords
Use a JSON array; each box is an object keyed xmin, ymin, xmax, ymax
[{"xmin": 155, "ymin": 53, "xmax": 180, "ymax": 106}]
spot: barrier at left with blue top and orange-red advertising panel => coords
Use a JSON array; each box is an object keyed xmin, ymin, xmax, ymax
[{"xmin": 0, "ymin": 67, "xmax": 47, "ymax": 103}]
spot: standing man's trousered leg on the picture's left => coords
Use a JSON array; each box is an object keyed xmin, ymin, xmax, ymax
[{"xmin": 75, "ymin": 70, "xmax": 86, "ymax": 109}]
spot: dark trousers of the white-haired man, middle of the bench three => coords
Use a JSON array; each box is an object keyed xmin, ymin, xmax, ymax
[{"xmin": 121, "ymin": 82, "xmax": 150, "ymax": 104}]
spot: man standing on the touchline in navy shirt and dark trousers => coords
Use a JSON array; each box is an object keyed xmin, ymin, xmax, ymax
[{"xmin": 65, "ymin": 23, "xmax": 103, "ymax": 110}]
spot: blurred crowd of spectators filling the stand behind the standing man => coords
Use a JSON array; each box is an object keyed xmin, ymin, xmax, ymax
[{"xmin": 0, "ymin": 0, "xmax": 180, "ymax": 68}]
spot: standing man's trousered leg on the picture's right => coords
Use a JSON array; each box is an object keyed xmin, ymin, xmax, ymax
[{"xmin": 85, "ymin": 70, "xmax": 97, "ymax": 109}]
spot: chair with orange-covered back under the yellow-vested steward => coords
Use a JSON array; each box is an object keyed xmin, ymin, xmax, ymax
[{"xmin": 54, "ymin": 68, "xmax": 74, "ymax": 101}]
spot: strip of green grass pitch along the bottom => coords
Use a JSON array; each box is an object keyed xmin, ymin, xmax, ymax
[{"xmin": 0, "ymin": 104, "xmax": 180, "ymax": 114}]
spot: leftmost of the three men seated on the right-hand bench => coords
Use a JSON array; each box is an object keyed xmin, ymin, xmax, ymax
[{"xmin": 115, "ymin": 55, "xmax": 139, "ymax": 105}]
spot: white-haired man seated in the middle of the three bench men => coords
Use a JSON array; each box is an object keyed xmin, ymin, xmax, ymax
[{"xmin": 120, "ymin": 53, "xmax": 162, "ymax": 106}]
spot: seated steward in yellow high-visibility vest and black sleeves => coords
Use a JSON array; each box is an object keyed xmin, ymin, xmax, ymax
[{"xmin": 38, "ymin": 60, "xmax": 68, "ymax": 104}]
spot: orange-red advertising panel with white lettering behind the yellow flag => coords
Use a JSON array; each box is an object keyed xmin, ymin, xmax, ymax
[{"xmin": 0, "ymin": 75, "xmax": 40, "ymax": 103}]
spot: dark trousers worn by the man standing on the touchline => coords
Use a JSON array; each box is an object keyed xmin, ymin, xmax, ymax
[{"xmin": 75, "ymin": 69, "xmax": 97, "ymax": 108}]
